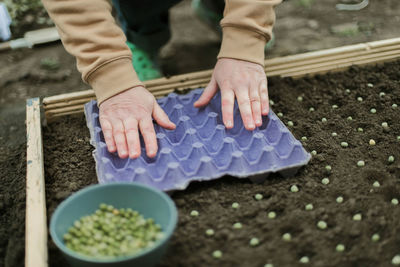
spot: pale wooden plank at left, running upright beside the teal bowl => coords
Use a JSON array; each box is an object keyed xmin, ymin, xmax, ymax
[{"xmin": 25, "ymin": 98, "xmax": 48, "ymax": 267}]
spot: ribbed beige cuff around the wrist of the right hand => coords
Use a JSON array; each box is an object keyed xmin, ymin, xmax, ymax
[{"xmin": 218, "ymin": 26, "xmax": 266, "ymax": 66}]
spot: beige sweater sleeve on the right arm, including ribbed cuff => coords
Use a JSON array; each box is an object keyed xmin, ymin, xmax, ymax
[{"xmin": 218, "ymin": 0, "xmax": 281, "ymax": 66}]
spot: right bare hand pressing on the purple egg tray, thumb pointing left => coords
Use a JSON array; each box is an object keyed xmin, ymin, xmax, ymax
[{"xmin": 194, "ymin": 58, "xmax": 269, "ymax": 130}]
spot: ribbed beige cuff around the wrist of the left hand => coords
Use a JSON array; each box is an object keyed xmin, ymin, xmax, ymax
[{"xmin": 87, "ymin": 57, "xmax": 143, "ymax": 105}]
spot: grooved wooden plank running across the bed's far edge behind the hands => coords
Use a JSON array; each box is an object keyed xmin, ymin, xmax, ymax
[{"xmin": 43, "ymin": 38, "xmax": 400, "ymax": 121}]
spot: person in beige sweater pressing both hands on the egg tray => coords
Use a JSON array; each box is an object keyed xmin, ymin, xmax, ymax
[{"xmin": 42, "ymin": 0, "xmax": 281, "ymax": 158}]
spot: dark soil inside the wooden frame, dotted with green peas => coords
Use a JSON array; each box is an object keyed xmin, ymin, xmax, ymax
[{"xmin": 40, "ymin": 62, "xmax": 400, "ymax": 267}]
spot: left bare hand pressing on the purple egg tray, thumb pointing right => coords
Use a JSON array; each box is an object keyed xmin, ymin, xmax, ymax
[{"xmin": 99, "ymin": 86, "xmax": 176, "ymax": 158}]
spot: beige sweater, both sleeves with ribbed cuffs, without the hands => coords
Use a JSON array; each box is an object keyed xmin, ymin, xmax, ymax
[{"xmin": 43, "ymin": 0, "xmax": 281, "ymax": 103}]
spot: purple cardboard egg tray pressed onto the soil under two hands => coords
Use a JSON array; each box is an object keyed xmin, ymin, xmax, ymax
[{"xmin": 85, "ymin": 89, "xmax": 311, "ymax": 191}]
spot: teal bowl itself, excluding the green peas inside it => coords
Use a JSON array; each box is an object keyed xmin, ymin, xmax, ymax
[{"xmin": 50, "ymin": 183, "xmax": 178, "ymax": 267}]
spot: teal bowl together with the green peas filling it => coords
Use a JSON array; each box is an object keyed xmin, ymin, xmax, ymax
[{"xmin": 50, "ymin": 183, "xmax": 178, "ymax": 267}]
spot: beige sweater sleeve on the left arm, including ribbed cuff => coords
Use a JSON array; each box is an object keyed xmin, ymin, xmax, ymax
[{"xmin": 42, "ymin": 0, "xmax": 142, "ymax": 104}]
